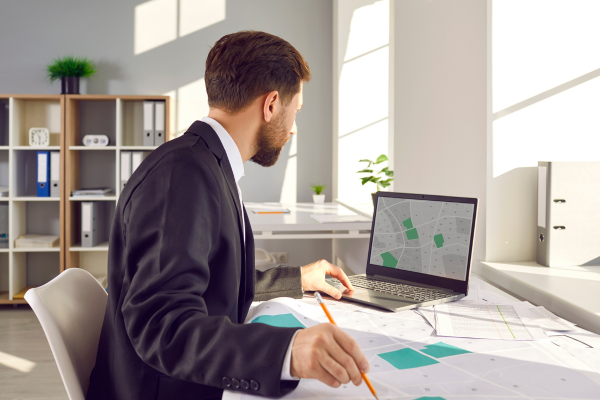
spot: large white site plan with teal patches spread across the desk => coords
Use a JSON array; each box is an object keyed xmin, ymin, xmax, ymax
[{"xmin": 223, "ymin": 298, "xmax": 600, "ymax": 400}]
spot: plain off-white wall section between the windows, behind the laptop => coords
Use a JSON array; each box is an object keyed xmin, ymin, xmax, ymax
[{"xmin": 393, "ymin": 0, "xmax": 488, "ymax": 259}]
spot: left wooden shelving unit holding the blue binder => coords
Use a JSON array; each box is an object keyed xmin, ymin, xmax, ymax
[{"xmin": 0, "ymin": 95, "xmax": 65, "ymax": 304}]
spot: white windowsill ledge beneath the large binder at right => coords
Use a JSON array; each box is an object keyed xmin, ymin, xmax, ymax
[{"xmin": 474, "ymin": 261, "xmax": 600, "ymax": 334}]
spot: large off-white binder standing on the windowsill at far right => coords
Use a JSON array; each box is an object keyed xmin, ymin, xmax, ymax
[{"xmin": 537, "ymin": 162, "xmax": 600, "ymax": 267}]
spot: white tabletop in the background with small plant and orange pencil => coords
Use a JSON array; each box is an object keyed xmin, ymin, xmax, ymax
[{"xmin": 244, "ymin": 203, "xmax": 371, "ymax": 232}]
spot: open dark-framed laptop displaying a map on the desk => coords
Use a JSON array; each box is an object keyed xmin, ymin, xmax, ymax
[{"xmin": 327, "ymin": 192, "xmax": 477, "ymax": 311}]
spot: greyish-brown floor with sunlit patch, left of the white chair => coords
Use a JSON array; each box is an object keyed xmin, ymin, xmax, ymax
[{"xmin": 0, "ymin": 306, "xmax": 68, "ymax": 400}]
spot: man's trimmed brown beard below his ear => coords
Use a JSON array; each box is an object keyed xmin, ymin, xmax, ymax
[{"xmin": 251, "ymin": 110, "xmax": 289, "ymax": 167}]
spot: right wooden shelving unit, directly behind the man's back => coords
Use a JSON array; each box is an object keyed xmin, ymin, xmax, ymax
[{"xmin": 64, "ymin": 95, "xmax": 170, "ymax": 282}]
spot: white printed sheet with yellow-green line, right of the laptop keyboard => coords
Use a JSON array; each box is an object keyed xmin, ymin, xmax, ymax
[{"xmin": 435, "ymin": 303, "xmax": 548, "ymax": 340}]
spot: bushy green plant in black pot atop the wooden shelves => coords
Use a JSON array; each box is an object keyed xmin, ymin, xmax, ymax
[{"xmin": 46, "ymin": 56, "xmax": 96, "ymax": 94}]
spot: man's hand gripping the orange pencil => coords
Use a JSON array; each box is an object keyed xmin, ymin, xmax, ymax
[{"xmin": 290, "ymin": 323, "xmax": 369, "ymax": 388}]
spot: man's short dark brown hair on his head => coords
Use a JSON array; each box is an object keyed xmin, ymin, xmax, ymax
[{"xmin": 204, "ymin": 31, "xmax": 311, "ymax": 113}]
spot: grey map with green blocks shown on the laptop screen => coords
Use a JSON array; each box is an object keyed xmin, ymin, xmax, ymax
[{"xmin": 370, "ymin": 197, "xmax": 474, "ymax": 281}]
